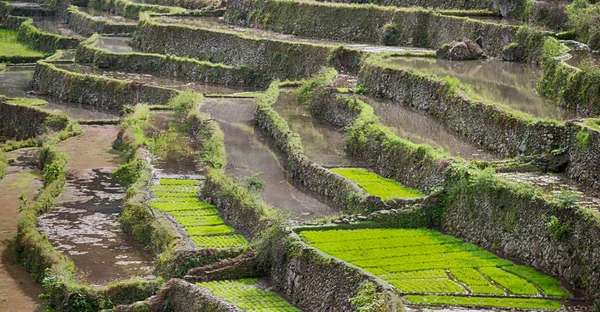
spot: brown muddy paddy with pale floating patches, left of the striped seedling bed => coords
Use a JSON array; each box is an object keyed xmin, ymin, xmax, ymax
[{"xmin": 38, "ymin": 126, "xmax": 153, "ymax": 285}]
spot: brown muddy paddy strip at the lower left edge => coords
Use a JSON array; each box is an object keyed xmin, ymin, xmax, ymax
[{"xmin": 0, "ymin": 149, "xmax": 43, "ymax": 311}]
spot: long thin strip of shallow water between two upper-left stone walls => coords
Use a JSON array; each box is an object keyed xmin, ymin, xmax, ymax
[{"xmin": 57, "ymin": 64, "xmax": 256, "ymax": 94}]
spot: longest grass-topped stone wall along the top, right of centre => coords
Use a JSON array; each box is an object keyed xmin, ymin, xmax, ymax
[{"xmin": 226, "ymin": 0, "xmax": 541, "ymax": 58}]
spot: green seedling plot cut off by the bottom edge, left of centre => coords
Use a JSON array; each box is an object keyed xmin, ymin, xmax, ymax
[{"xmin": 196, "ymin": 278, "xmax": 300, "ymax": 312}]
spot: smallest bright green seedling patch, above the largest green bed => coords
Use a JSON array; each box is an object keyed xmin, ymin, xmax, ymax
[{"xmin": 331, "ymin": 168, "xmax": 425, "ymax": 200}]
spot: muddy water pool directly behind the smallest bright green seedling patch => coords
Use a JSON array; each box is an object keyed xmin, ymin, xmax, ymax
[{"xmin": 273, "ymin": 90, "xmax": 353, "ymax": 167}]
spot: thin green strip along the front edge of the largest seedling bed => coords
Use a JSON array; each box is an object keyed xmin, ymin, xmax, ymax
[{"xmin": 406, "ymin": 295, "xmax": 562, "ymax": 310}]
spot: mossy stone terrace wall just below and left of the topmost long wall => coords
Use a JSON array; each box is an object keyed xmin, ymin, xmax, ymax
[{"xmin": 133, "ymin": 18, "xmax": 334, "ymax": 80}]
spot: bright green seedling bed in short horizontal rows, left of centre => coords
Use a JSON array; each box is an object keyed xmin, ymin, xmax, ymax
[{"xmin": 148, "ymin": 179, "xmax": 248, "ymax": 249}]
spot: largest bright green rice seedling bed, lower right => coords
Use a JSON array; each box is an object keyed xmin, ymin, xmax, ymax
[{"xmin": 300, "ymin": 229, "xmax": 571, "ymax": 302}]
